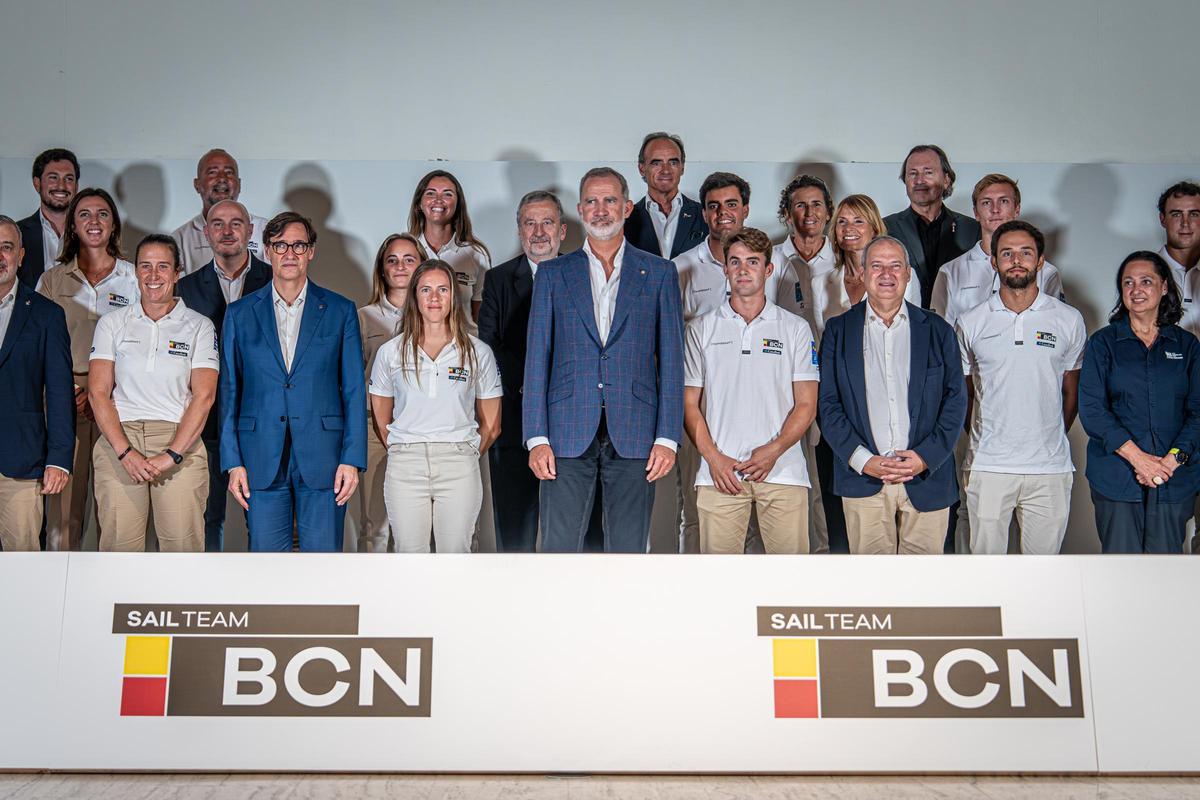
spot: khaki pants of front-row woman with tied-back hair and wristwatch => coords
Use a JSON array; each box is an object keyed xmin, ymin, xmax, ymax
[{"xmin": 92, "ymin": 420, "xmax": 209, "ymax": 553}]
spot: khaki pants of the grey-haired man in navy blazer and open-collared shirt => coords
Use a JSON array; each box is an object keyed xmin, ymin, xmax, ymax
[{"xmin": 841, "ymin": 483, "xmax": 950, "ymax": 555}]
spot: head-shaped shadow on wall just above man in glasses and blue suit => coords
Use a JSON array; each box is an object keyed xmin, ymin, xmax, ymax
[{"xmin": 283, "ymin": 162, "xmax": 372, "ymax": 306}]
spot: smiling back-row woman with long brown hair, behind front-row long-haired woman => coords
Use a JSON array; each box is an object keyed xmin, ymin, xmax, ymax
[{"xmin": 408, "ymin": 169, "xmax": 492, "ymax": 335}]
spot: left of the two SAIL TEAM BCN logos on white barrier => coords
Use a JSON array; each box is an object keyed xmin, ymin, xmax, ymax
[{"xmin": 113, "ymin": 603, "xmax": 433, "ymax": 717}]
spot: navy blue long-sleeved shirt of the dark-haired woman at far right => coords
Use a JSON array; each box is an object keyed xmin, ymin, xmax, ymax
[{"xmin": 1079, "ymin": 318, "xmax": 1200, "ymax": 503}]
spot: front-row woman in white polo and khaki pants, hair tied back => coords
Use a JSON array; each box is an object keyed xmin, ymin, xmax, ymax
[{"xmin": 88, "ymin": 234, "xmax": 218, "ymax": 553}]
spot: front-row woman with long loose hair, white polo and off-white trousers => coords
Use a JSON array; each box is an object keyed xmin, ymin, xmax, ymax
[{"xmin": 370, "ymin": 259, "xmax": 503, "ymax": 553}]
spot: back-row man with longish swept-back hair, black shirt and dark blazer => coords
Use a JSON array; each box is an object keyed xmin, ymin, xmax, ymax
[{"xmin": 883, "ymin": 144, "xmax": 979, "ymax": 308}]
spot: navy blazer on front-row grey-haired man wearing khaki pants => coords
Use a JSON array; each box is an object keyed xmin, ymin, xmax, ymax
[{"xmin": 817, "ymin": 300, "xmax": 967, "ymax": 511}]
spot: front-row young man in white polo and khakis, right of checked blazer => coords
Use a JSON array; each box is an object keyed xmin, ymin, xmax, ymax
[{"xmin": 684, "ymin": 228, "xmax": 818, "ymax": 553}]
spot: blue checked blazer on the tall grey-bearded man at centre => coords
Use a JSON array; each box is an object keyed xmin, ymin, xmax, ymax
[{"xmin": 522, "ymin": 242, "xmax": 683, "ymax": 458}]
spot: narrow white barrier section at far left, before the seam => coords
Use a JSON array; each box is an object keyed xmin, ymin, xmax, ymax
[{"xmin": 0, "ymin": 554, "xmax": 68, "ymax": 766}]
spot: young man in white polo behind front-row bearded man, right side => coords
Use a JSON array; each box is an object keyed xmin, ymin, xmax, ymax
[{"xmin": 929, "ymin": 173, "xmax": 1062, "ymax": 326}]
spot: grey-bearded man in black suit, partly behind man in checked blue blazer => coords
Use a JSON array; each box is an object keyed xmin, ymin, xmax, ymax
[{"xmin": 479, "ymin": 191, "xmax": 566, "ymax": 553}]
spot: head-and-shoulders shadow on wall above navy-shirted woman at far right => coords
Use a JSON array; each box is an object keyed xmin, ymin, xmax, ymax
[{"xmin": 1046, "ymin": 164, "xmax": 1137, "ymax": 331}]
